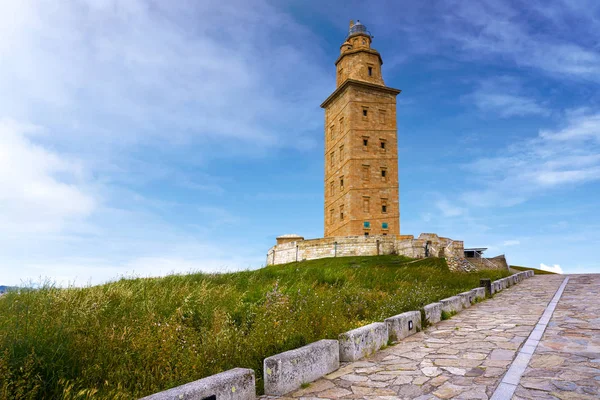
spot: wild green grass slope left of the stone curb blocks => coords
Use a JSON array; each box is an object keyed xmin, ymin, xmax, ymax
[{"xmin": 0, "ymin": 256, "xmax": 507, "ymax": 399}]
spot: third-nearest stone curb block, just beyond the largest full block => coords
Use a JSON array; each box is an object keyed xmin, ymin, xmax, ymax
[{"xmin": 338, "ymin": 322, "xmax": 388, "ymax": 361}]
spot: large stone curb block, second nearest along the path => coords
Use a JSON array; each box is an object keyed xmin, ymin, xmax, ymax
[{"xmin": 264, "ymin": 339, "xmax": 340, "ymax": 399}]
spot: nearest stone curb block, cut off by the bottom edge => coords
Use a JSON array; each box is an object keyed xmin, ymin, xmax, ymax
[{"xmin": 140, "ymin": 368, "xmax": 256, "ymax": 400}]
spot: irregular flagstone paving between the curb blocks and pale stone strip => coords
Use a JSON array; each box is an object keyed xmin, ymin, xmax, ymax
[{"xmin": 262, "ymin": 275, "xmax": 564, "ymax": 400}]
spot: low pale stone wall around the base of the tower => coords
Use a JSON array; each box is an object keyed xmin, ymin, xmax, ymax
[{"xmin": 267, "ymin": 233, "xmax": 464, "ymax": 265}]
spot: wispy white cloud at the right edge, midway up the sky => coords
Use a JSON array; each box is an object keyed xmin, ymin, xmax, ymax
[{"xmin": 462, "ymin": 112, "xmax": 600, "ymax": 206}]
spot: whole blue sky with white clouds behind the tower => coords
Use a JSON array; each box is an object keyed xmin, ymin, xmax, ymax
[{"xmin": 0, "ymin": 0, "xmax": 600, "ymax": 285}]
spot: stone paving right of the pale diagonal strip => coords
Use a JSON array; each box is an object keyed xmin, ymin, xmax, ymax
[{"xmin": 513, "ymin": 275, "xmax": 600, "ymax": 399}]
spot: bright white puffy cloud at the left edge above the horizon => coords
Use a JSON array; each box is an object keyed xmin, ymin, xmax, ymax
[{"xmin": 0, "ymin": 119, "xmax": 97, "ymax": 235}]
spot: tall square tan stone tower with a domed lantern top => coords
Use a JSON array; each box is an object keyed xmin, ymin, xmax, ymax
[{"xmin": 321, "ymin": 21, "xmax": 400, "ymax": 237}]
